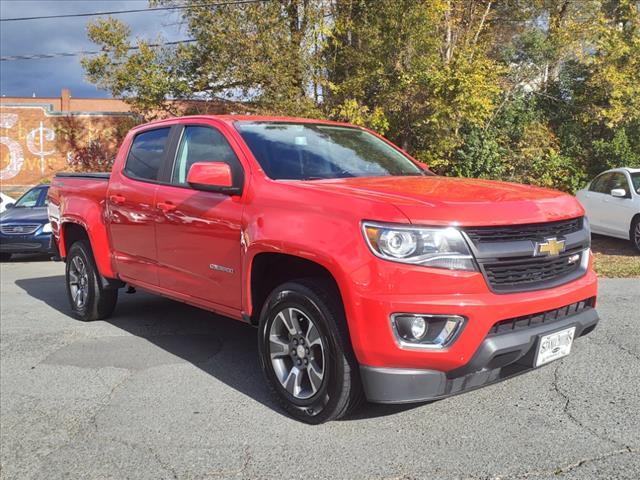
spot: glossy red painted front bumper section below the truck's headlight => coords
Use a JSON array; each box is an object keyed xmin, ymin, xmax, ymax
[{"xmin": 343, "ymin": 253, "xmax": 597, "ymax": 372}]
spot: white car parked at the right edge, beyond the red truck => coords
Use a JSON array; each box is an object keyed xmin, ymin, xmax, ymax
[{"xmin": 576, "ymin": 168, "xmax": 640, "ymax": 251}]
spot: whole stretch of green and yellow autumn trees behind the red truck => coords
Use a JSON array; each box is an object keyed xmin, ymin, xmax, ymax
[{"xmin": 83, "ymin": 0, "xmax": 640, "ymax": 191}]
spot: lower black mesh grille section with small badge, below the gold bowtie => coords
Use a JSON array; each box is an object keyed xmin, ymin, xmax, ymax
[{"xmin": 480, "ymin": 250, "xmax": 583, "ymax": 291}]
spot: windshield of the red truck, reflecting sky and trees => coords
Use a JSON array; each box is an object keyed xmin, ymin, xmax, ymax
[{"xmin": 235, "ymin": 121, "xmax": 430, "ymax": 180}]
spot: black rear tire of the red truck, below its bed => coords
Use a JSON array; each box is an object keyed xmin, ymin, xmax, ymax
[{"xmin": 65, "ymin": 240, "xmax": 118, "ymax": 322}]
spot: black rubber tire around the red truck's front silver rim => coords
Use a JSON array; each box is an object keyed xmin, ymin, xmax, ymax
[{"xmin": 258, "ymin": 278, "xmax": 363, "ymax": 425}]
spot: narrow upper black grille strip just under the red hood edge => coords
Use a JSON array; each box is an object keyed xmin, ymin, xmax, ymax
[{"xmin": 464, "ymin": 217, "xmax": 583, "ymax": 244}]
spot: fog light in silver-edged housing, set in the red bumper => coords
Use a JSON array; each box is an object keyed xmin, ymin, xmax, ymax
[{"xmin": 391, "ymin": 313, "xmax": 464, "ymax": 349}]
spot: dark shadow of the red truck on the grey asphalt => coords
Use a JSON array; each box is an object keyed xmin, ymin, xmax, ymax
[{"xmin": 15, "ymin": 275, "xmax": 420, "ymax": 421}]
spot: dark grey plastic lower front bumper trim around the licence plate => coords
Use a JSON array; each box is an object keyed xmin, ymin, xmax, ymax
[{"xmin": 360, "ymin": 308, "xmax": 599, "ymax": 403}]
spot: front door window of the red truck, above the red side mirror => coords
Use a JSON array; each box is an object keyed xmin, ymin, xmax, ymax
[{"xmin": 171, "ymin": 126, "xmax": 242, "ymax": 185}]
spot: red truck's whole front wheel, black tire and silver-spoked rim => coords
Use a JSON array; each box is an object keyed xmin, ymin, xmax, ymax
[{"xmin": 258, "ymin": 279, "xmax": 363, "ymax": 424}]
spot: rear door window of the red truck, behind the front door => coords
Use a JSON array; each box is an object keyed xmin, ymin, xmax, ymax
[{"xmin": 124, "ymin": 127, "xmax": 171, "ymax": 182}]
